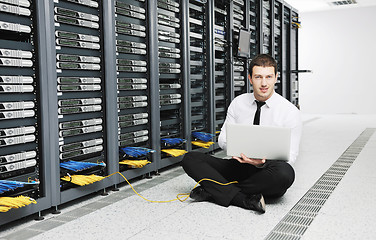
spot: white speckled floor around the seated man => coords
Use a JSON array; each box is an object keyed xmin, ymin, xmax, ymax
[{"xmin": 0, "ymin": 115, "xmax": 376, "ymax": 240}]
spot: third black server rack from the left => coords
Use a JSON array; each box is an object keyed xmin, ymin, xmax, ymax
[{"xmin": 114, "ymin": 0, "xmax": 157, "ymax": 181}]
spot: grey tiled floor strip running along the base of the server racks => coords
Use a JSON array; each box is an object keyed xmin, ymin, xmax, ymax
[{"xmin": 4, "ymin": 168, "xmax": 184, "ymax": 240}]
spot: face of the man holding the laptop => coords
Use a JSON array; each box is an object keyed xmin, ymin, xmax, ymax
[{"xmin": 248, "ymin": 66, "xmax": 278, "ymax": 102}]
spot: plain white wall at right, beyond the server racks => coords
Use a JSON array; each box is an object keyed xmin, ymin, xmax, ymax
[{"xmin": 299, "ymin": 7, "xmax": 376, "ymax": 114}]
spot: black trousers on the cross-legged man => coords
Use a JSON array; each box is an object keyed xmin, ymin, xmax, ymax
[{"xmin": 182, "ymin": 152, "xmax": 295, "ymax": 207}]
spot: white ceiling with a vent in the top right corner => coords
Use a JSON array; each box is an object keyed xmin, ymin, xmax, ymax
[{"xmin": 285, "ymin": 0, "xmax": 376, "ymax": 12}]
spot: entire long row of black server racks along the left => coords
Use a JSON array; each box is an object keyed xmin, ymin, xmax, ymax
[{"xmin": 0, "ymin": 0, "xmax": 299, "ymax": 224}]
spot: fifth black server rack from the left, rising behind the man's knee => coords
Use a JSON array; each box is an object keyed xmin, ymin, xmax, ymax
[{"xmin": 187, "ymin": 0, "xmax": 214, "ymax": 151}]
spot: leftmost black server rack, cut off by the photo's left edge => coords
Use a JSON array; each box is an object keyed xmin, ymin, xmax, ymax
[{"xmin": 0, "ymin": 1, "xmax": 51, "ymax": 224}]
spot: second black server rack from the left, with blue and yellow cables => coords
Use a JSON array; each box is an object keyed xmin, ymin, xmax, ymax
[{"xmin": 47, "ymin": 0, "xmax": 114, "ymax": 206}]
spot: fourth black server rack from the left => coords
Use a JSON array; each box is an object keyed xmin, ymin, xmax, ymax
[{"xmin": 157, "ymin": 0, "xmax": 187, "ymax": 168}]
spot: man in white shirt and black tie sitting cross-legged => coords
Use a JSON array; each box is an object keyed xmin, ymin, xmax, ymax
[{"xmin": 182, "ymin": 54, "xmax": 302, "ymax": 213}]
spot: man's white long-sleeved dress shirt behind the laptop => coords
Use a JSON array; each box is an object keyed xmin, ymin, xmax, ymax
[{"xmin": 218, "ymin": 92, "xmax": 302, "ymax": 164}]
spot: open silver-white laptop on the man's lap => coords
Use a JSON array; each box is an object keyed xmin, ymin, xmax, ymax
[{"xmin": 226, "ymin": 123, "xmax": 291, "ymax": 161}]
